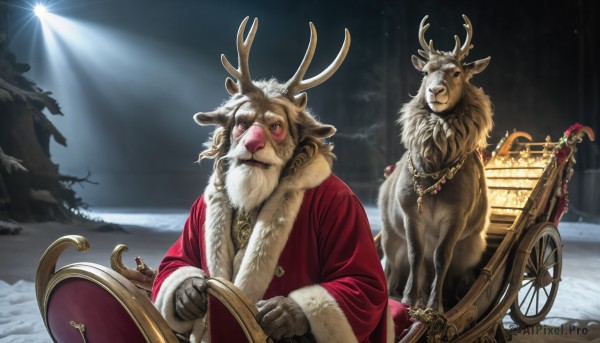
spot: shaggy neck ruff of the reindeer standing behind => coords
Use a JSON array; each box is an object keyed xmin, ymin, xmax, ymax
[{"xmin": 398, "ymin": 84, "xmax": 493, "ymax": 172}]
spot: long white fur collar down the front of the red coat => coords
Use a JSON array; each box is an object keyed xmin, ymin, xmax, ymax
[{"xmin": 204, "ymin": 155, "xmax": 331, "ymax": 303}]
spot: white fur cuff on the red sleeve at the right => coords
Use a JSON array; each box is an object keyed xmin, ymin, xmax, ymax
[{"xmin": 289, "ymin": 285, "xmax": 358, "ymax": 343}]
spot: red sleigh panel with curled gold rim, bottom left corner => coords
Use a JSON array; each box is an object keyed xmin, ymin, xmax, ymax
[{"xmin": 36, "ymin": 236, "xmax": 178, "ymax": 343}]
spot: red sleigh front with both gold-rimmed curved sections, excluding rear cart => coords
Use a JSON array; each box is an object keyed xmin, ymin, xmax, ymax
[{"xmin": 35, "ymin": 235, "xmax": 267, "ymax": 343}]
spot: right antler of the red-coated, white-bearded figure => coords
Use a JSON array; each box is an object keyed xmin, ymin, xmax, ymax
[{"xmin": 285, "ymin": 22, "xmax": 350, "ymax": 95}]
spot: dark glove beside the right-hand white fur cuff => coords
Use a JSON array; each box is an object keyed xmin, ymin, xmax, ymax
[{"xmin": 256, "ymin": 296, "xmax": 309, "ymax": 340}]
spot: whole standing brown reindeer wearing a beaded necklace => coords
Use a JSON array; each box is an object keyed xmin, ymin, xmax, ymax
[{"xmin": 378, "ymin": 15, "xmax": 493, "ymax": 312}]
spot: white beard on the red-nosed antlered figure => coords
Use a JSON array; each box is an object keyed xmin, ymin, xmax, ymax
[{"xmin": 225, "ymin": 163, "xmax": 282, "ymax": 212}]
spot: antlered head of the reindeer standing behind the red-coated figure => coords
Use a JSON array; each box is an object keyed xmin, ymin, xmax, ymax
[{"xmin": 412, "ymin": 14, "xmax": 490, "ymax": 113}]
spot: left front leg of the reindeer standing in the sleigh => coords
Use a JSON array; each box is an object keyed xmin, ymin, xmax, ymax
[{"xmin": 402, "ymin": 216, "xmax": 425, "ymax": 307}]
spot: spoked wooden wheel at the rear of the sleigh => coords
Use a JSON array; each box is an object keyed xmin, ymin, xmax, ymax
[{"xmin": 510, "ymin": 223, "xmax": 562, "ymax": 326}]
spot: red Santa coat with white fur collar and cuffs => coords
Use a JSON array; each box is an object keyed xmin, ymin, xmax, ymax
[{"xmin": 152, "ymin": 157, "xmax": 406, "ymax": 342}]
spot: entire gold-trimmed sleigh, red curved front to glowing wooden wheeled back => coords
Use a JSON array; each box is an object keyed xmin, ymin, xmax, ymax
[{"xmin": 36, "ymin": 124, "xmax": 594, "ymax": 343}]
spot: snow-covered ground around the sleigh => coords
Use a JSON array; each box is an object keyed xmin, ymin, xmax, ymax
[{"xmin": 0, "ymin": 207, "xmax": 600, "ymax": 343}]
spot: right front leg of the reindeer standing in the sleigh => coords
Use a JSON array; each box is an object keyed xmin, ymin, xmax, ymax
[{"xmin": 427, "ymin": 218, "xmax": 467, "ymax": 313}]
